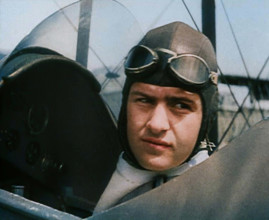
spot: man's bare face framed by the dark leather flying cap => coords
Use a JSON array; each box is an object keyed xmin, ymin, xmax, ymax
[{"xmin": 127, "ymin": 82, "xmax": 202, "ymax": 171}]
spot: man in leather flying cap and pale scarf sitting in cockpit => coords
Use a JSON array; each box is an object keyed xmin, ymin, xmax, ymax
[{"xmin": 95, "ymin": 22, "xmax": 218, "ymax": 213}]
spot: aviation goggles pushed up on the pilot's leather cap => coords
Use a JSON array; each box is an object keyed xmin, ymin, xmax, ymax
[{"xmin": 124, "ymin": 45, "xmax": 218, "ymax": 87}]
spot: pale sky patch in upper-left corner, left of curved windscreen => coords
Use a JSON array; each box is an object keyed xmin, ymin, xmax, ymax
[{"xmin": 0, "ymin": 0, "xmax": 75, "ymax": 51}]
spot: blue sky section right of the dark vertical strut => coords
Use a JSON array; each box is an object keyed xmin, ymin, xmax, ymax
[{"xmin": 216, "ymin": 0, "xmax": 269, "ymax": 79}]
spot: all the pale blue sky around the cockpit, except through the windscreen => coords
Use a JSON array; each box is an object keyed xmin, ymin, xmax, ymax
[{"xmin": 0, "ymin": 0, "xmax": 269, "ymax": 79}]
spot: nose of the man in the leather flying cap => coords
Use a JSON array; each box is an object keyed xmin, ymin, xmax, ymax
[{"xmin": 146, "ymin": 105, "xmax": 170, "ymax": 134}]
